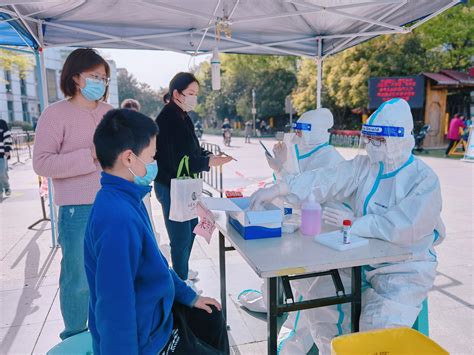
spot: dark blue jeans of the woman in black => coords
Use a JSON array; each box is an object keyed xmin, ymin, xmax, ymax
[{"xmin": 155, "ymin": 182, "xmax": 198, "ymax": 280}]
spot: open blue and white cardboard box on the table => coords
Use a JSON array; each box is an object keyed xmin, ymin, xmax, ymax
[{"xmin": 202, "ymin": 197, "xmax": 283, "ymax": 239}]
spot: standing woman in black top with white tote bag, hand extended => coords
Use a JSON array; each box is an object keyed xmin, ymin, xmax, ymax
[{"xmin": 155, "ymin": 73, "xmax": 232, "ymax": 280}]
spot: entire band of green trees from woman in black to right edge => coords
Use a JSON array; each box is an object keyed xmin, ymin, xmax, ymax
[{"xmin": 187, "ymin": 0, "xmax": 474, "ymax": 128}]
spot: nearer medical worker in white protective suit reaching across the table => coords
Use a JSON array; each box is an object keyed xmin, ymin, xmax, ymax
[{"xmin": 251, "ymin": 99, "xmax": 445, "ymax": 354}]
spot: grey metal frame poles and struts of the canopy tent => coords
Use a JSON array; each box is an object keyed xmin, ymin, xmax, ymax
[{"xmin": 0, "ymin": 0, "xmax": 461, "ymax": 247}]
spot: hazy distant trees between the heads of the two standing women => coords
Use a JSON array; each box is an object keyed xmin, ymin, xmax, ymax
[{"xmin": 117, "ymin": 71, "xmax": 164, "ymax": 118}]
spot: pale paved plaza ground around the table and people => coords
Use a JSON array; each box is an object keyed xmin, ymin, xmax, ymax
[{"xmin": 0, "ymin": 137, "xmax": 474, "ymax": 354}]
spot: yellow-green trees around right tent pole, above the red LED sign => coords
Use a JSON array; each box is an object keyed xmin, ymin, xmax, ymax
[{"xmin": 293, "ymin": 0, "xmax": 474, "ymax": 122}]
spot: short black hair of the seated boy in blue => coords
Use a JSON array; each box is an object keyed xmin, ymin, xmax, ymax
[{"xmin": 94, "ymin": 109, "xmax": 159, "ymax": 169}]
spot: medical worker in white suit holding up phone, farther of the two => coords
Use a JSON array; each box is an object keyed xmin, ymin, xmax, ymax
[{"xmin": 238, "ymin": 108, "xmax": 353, "ymax": 355}]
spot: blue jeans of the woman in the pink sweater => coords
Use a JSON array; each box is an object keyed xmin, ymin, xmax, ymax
[{"xmin": 58, "ymin": 205, "xmax": 92, "ymax": 340}]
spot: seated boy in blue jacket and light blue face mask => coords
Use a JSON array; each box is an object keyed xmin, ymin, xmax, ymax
[{"xmin": 84, "ymin": 110, "xmax": 229, "ymax": 355}]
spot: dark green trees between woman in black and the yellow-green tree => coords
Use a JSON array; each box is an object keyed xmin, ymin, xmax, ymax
[{"xmin": 196, "ymin": 54, "xmax": 297, "ymax": 127}]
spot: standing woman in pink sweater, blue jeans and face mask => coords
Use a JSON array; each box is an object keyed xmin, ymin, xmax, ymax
[{"xmin": 33, "ymin": 49, "xmax": 112, "ymax": 339}]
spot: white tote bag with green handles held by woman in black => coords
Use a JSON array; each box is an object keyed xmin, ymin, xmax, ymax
[{"xmin": 169, "ymin": 155, "xmax": 202, "ymax": 222}]
